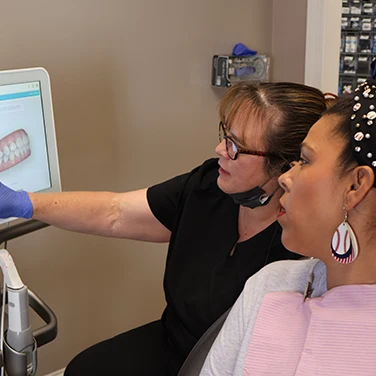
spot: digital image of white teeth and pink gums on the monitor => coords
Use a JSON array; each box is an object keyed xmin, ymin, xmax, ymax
[{"xmin": 0, "ymin": 129, "xmax": 31, "ymax": 172}]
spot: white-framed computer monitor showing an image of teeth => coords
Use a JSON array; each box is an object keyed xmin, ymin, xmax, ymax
[{"xmin": 0, "ymin": 68, "xmax": 61, "ymax": 222}]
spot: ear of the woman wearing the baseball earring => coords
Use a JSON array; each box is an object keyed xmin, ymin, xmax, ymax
[{"xmin": 345, "ymin": 166, "xmax": 375, "ymax": 210}]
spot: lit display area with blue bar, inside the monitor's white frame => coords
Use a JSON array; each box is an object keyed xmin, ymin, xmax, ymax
[{"xmin": 0, "ymin": 82, "xmax": 51, "ymax": 192}]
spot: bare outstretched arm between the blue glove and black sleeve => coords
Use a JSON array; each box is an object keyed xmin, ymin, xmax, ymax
[{"xmin": 29, "ymin": 189, "xmax": 171, "ymax": 242}]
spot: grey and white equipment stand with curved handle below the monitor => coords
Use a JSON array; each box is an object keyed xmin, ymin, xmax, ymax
[{"xmin": 0, "ymin": 220, "xmax": 57, "ymax": 376}]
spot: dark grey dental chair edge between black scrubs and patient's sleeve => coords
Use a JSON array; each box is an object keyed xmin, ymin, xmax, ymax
[{"xmin": 178, "ymin": 307, "xmax": 232, "ymax": 376}]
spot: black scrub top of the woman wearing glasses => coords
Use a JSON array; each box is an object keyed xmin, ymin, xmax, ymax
[{"xmin": 147, "ymin": 159, "xmax": 301, "ymax": 359}]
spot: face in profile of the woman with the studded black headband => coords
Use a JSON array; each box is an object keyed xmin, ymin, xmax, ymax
[{"xmin": 278, "ymin": 116, "xmax": 346, "ymax": 261}]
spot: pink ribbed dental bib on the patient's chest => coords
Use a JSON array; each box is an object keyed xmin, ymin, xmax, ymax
[{"xmin": 243, "ymin": 285, "xmax": 376, "ymax": 376}]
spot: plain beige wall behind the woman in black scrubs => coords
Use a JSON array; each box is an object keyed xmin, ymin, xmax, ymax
[{"xmin": 0, "ymin": 0, "xmax": 284, "ymax": 375}]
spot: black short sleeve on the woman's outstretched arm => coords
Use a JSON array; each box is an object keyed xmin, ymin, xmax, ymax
[{"xmin": 147, "ymin": 173, "xmax": 190, "ymax": 231}]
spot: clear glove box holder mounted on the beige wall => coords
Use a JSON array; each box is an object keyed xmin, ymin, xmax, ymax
[{"xmin": 211, "ymin": 55, "xmax": 270, "ymax": 87}]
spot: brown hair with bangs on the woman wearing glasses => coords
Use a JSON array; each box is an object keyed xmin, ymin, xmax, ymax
[{"xmin": 219, "ymin": 82, "xmax": 327, "ymax": 176}]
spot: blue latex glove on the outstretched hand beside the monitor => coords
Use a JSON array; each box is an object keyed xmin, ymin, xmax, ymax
[{"xmin": 0, "ymin": 183, "xmax": 33, "ymax": 219}]
